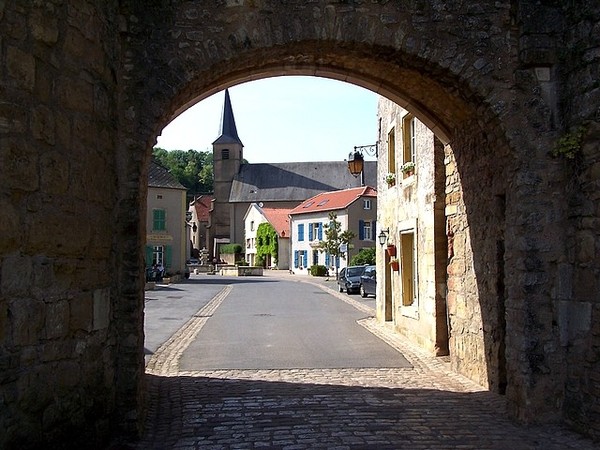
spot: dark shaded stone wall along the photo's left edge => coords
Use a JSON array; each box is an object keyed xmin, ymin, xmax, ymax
[{"xmin": 0, "ymin": 1, "xmax": 119, "ymax": 448}]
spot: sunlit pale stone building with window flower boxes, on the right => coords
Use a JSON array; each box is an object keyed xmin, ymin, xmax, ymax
[{"xmin": 376, "ymin": 97, "xmax": 451, "ymax": 364}]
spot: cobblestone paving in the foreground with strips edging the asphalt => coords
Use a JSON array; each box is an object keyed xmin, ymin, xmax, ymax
[{"xmin": 134, "ymin": 274, "xmax": 598, "ymax": 450}]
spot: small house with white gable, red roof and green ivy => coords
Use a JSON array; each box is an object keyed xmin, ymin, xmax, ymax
[{"xmin": 244, "ymin": 203, "xmax": 291, "ymax": 270}]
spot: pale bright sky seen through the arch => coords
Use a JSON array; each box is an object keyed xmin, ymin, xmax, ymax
[{"xmin": 156, "ymin": 76, "xmax": 378, "ymax": 163}]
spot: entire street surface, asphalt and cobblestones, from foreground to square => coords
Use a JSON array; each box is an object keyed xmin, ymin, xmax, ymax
[{"xmin": 135, "ymin": 272, "xmax": 595, "ymax": 449}]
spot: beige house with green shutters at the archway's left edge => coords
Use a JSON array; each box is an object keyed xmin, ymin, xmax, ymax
[{"xmin": 145, "ymin": 160, "xmax": 189, "ymax": 274}]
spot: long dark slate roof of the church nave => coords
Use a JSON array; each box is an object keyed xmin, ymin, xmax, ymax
[{"xmin": 229, "ymin": 161, "xmax": 377, "ymax": 203}]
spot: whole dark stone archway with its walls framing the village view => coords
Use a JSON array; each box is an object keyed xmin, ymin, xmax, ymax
[{"xmin": 0, "ymin": 0, "xmax": 600, "ymax": 445}]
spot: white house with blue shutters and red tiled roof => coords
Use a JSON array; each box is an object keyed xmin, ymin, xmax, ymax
[{"xmin": 290, "ymin": 186, "xmax": 377, "ymax": 272}]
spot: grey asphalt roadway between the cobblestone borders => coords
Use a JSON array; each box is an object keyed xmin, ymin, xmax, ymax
[{"xmin": 179, "ymin": 278, "xmax": 410, "ymax": 371}]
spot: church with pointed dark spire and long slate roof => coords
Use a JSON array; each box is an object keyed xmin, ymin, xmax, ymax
[{"xmin": 190, "ymin": 89, "xmax": 377, "ymax": 259}]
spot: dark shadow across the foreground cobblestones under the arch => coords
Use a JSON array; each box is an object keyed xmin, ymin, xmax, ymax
[{"xmin": 130, "ymin": 370, "xmax": 596, "ymax": 450}]
